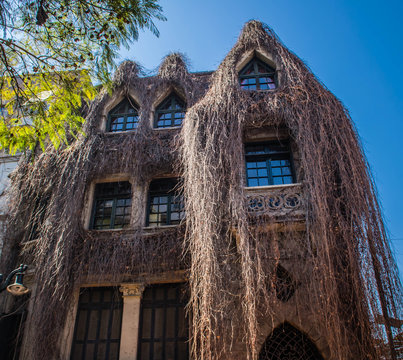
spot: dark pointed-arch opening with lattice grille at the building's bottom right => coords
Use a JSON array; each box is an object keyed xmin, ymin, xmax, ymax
[{"xmin": 259, "ymin": 323, "xmax": 323, "ymax": 360}]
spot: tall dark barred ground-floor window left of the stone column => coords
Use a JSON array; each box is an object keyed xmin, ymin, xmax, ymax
[{"xmin": 71, "ymin": 287, "xmax": 123, "ymax": 360}]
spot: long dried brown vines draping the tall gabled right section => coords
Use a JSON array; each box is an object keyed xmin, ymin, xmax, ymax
[{"xmin": 181, "ymin": 21, "xmax": 402, "ymax": 359}]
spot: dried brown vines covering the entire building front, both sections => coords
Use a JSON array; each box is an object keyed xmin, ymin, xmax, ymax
[{"xmin": 3, "ymin": 21, "xmax": 402, "ymax": 360}]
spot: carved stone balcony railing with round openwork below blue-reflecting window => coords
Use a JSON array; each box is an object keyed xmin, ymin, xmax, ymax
[{"xmin": 245, "ymin": 184, "xmax": 305, "ymax": 217}]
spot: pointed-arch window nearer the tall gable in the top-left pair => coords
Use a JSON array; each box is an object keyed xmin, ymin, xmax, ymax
[{"xmin": 154, "ymin": 93, "xmax": 185, "ymax": 128}]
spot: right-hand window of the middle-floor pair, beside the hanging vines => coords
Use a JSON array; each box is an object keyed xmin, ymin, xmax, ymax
[{"xmin": 147, "ymin": 179, "xmax": 185, "ymax": 226}]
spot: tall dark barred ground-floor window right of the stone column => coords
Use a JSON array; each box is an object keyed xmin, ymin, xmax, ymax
[{"xmin": 137, "ymin": 284, "xmax": 189, "ymax": 360}]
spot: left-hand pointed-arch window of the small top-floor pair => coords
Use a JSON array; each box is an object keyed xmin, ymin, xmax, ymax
[{"xmin": 107, "ymin": 98, "xmax": 139, "ymax": 132}]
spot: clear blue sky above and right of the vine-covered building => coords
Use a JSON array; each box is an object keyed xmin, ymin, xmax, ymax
[{"xmin": 121, "ymin": 0, "xmax": 403, "ymax": 274}]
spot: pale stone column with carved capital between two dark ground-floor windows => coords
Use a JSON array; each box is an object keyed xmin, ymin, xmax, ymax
[{"xmin": 119, "ymin": 284, "xmax": 144, "ymax": 360}]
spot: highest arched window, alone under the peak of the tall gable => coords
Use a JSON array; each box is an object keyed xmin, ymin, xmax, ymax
[{"xmin": 239, "ymin": 57, "xmax": 277, "ymax": 90}]
